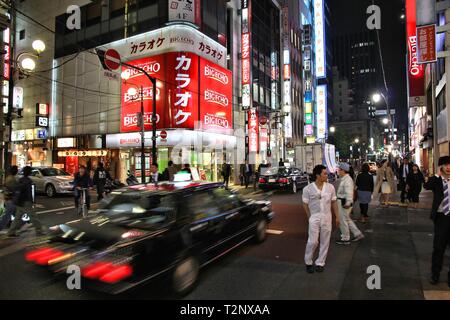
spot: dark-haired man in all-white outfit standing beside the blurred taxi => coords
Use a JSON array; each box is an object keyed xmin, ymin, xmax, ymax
[{"xmin": 302, "ymin": 165, "xmax": 339, "ymax": 273}]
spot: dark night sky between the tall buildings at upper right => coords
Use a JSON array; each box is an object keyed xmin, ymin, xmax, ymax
[{"xmin": 328, "ymin": 0, "xmax": 408, "ymax": 130}]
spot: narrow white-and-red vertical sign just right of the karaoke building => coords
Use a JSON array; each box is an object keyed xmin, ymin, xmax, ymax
[{"xmin": 241, "ymin": 0, "xmax": 253, "ymax": 109}]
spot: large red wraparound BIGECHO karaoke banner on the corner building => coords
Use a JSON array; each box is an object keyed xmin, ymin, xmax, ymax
[{"xmin": 121, "ymin": 52, "xmax": 233, "ymax": 132}]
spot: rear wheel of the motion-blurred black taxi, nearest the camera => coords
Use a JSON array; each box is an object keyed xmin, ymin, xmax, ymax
[{"xmin": 172, "ymin": 256, "xmax": 200, "ymax": 296}]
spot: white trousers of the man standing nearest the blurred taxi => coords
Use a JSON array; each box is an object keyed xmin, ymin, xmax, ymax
[{"xmin": 305, "ymin": 213, "xmax": 332, "ymax": 267}]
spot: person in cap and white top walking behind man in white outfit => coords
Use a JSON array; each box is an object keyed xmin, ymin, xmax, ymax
[{"xmin": 336, "ymin": 163, "xmax": 364, "ymax": 245}]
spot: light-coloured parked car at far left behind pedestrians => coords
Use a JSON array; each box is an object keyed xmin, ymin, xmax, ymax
[{"xmin": 19, "ymin": 167, "xmax": 73, "ymax": 198}]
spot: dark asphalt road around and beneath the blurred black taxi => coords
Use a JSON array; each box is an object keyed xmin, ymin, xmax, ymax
[{"xmin": 0, "ymin": 189, "xmax": 314, "ymax": 299}]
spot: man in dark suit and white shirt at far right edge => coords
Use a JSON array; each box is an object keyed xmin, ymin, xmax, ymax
[{"xmin": 425, "ymin": 156, "xmax": 450, "ymax": 287}]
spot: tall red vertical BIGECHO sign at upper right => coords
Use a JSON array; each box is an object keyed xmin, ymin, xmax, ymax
[{"xmin": 406, "ymin": 0, "xmax": 425, "ymax": 107}]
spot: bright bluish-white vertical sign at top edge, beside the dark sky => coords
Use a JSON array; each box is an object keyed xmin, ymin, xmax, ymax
[{"xmin": 314, "ymin": 0, "xmax": 326, "ymax": 79}]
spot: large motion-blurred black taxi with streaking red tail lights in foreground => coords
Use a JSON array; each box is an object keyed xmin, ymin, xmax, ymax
[{"xmin": 25, "ymin": 183, "xmax": 274, "ymax": 295}]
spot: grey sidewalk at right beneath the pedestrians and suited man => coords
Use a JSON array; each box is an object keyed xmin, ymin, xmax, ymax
[{"xmin": 340, "ymin": 191, "xmax": 450, "ymax": 300}]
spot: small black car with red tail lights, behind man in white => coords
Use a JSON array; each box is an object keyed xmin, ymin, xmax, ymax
[{"xmin": 258, "ymin": 167, "xmax": 309, "ymax": 193}]
